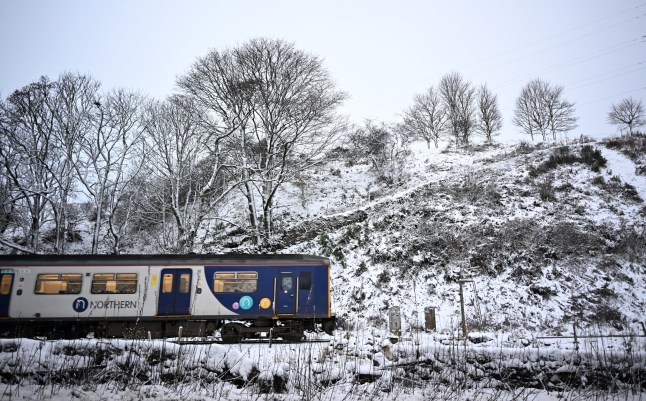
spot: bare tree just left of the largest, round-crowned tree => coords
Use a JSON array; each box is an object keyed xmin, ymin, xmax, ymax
[{"xmin": 146, "ymin": 95, "xmax": 238, "ymax": 252}]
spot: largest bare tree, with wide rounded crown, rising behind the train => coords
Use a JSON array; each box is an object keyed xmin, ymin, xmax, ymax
[{"xmin": 178, "ymin": 39, "xmax": 346, "ymax": 244}]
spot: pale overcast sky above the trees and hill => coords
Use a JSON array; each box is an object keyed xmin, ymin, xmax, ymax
[{"xmin": 0, "ymin": 0, "xmax": 646, "ymax": 139}]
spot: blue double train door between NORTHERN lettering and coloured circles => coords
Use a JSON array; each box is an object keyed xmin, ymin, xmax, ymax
[{"xmin": 157, "ymin": 269, "xmax": 193, "ymax": 316}]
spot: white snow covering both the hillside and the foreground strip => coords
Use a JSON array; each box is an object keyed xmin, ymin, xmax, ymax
[{"xmin": 0, "ymin": 136, "xmax": 646, "ymax": 401}]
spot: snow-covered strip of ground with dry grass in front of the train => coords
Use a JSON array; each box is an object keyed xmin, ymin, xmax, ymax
[{"xmin": 0, "ymin": 329, "xmax": 646, "ymax": 401}]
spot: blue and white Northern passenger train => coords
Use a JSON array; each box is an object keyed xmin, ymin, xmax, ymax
[{"xmin": 0, "ymin": 255, "xmax": 335, "ymax": 342}]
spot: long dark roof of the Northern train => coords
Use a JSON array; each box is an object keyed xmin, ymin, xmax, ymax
[{"xmin": 0, "ymin": 254, "xmax": 330, "ymax": 267}]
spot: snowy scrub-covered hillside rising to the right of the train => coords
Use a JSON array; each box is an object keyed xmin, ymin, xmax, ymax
[{"xmin": 272, "ymin": 136, "xmax": 646, "ymax": 335}]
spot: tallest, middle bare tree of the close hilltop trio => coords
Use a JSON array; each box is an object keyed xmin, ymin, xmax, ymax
[{"xmin": 439, "ymin": 72, "xmax": 476, "ymax": 147}]
